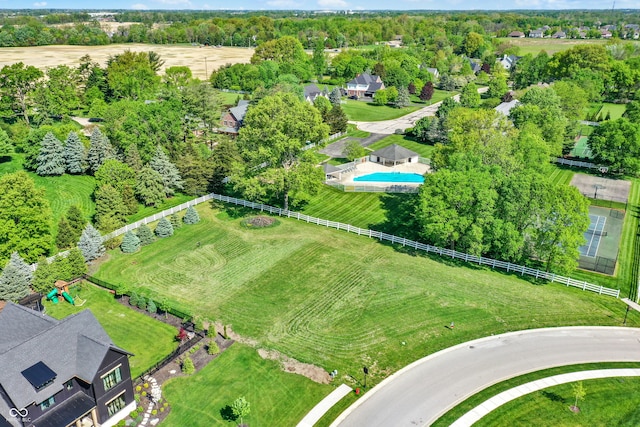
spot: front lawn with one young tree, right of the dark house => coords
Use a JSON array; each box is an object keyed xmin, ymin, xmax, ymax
[{"xmin": 162, "ymin": 343, "xmax": 332, "ymax": 427}]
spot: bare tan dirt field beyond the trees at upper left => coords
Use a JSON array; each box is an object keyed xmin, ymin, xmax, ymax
[{"xmin": 0, "ymin": 44, "xmax": 253, "ymax": 79}]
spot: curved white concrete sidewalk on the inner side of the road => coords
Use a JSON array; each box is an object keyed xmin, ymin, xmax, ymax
[{"xmin": 451, "ymin": 369, "xmax": 640, "ymax": 427}]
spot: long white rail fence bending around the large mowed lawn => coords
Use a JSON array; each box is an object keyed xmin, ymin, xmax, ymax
[{"xmin": 103, "ymin": 193, "xmax": 620, "ymax": 298}]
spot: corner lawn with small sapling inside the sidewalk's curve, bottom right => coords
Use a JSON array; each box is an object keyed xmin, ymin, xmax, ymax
[{"xmin": 474, "ymin": 378, "xmax": 640, "ymax": 427}]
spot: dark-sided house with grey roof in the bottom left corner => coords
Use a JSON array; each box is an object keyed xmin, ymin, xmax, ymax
[{"xmin": 0, "ymin": 302, "xmax": 136, "ymax": 427}]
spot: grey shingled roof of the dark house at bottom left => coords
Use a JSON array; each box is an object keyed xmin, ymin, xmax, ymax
[{"xmin": 0, "ymin": 302, "xmax": 129, "ymax": 419}]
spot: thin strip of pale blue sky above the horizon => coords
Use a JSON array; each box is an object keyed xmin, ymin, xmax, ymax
[{"xmin": 7, "ymin": 0, "xmax": 640, "ymax": 10}]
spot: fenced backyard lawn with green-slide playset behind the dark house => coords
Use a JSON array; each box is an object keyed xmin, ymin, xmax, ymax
[{"xmin": 45, "ymin": 283, "xmax": 177, "ymax": 378}]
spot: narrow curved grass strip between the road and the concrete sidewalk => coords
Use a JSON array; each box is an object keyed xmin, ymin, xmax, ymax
[{"xmin": 433, "ymin": 363, "xmax": 640, "ymax": 427}]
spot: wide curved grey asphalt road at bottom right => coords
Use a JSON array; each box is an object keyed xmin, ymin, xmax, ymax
[{"xmin": 332, "ymin": 327, "xmax": 640, "ymax": 427}]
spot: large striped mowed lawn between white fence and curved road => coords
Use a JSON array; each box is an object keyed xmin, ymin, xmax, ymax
[{"xmin": 96, "ymin": 205, "xmax": 640, "ymax": 392}]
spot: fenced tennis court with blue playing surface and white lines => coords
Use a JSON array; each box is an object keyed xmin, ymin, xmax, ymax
[{"xmin": 578, "ymin": 206, "xmax": 625, "ymax": 275}]
